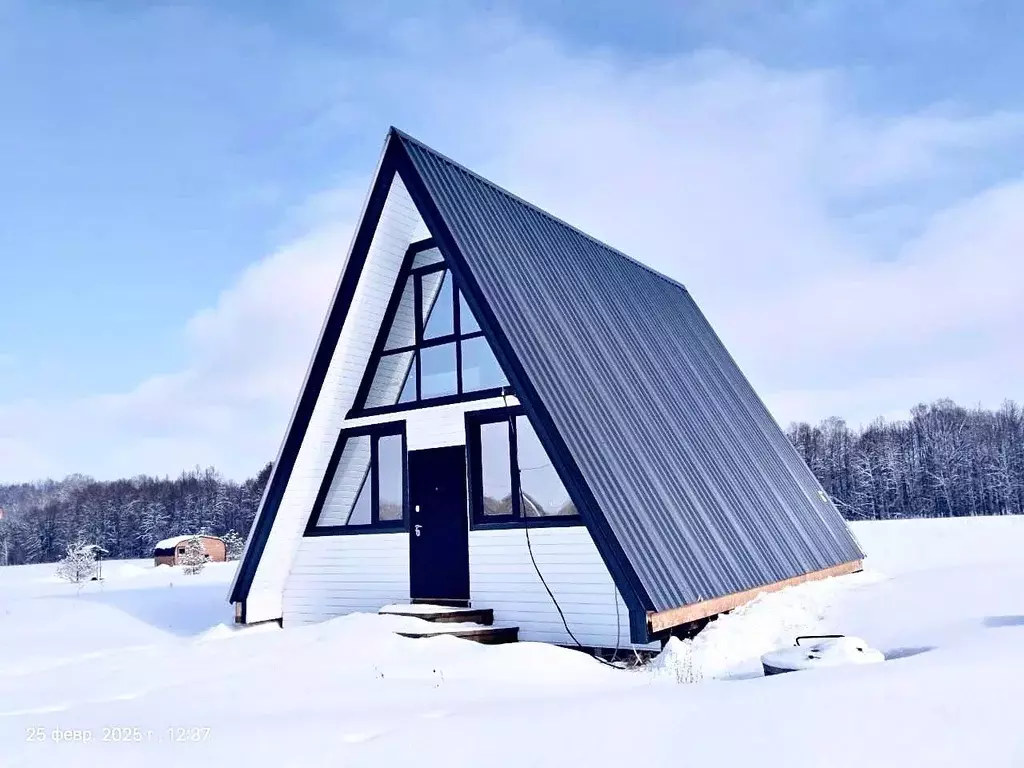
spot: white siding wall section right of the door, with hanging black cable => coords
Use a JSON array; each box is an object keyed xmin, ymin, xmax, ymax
[{"xmin": 469, "ymin": 525, "xmax": 657, "ymax": 648}]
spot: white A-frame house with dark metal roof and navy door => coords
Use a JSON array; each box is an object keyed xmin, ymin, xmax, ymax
[{"xmin": 229, "ymin": 129, "xmax": 862, "ymax": 647}]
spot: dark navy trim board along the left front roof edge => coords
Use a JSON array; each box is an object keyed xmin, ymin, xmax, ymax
[{"xmin": 228, "ymin": 134, "xmax": 399, "ymax": 602}]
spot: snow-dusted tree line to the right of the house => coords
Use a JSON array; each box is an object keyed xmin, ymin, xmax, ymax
[{"xmin": 787, "ymin": 400, "xmax": 1024, "ymax": 519}]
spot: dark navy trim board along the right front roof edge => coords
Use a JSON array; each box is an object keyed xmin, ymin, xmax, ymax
[{"xmin": 391, "ymin": 128, "xmax": 655, "ymax": 642}]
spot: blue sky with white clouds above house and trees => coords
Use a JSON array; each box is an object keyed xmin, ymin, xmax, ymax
[{"xmin": 0, "ymin": 0, "xmax": 1024, "ymax": 481}]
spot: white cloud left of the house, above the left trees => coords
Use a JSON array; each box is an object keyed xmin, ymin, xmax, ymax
[{"xmin": 0, "ymin": 218, "xmax": 357, "ymax": 480}]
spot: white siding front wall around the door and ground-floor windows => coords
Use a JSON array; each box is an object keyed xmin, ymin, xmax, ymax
[{"xmin": 284, "ymin": 396, "xmax": 656, "ymax": 648}]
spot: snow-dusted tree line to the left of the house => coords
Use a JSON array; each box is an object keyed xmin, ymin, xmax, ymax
[{"xmin": 0, "ymin": 464, "xmax": 270, "ymax": 565}]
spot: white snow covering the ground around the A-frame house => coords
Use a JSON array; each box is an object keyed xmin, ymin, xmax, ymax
[{"xmin": 0, "ymin": 518, "xmax": 1024, "ymax": 768}]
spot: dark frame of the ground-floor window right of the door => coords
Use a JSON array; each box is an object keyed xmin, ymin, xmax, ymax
[{"xmin": 466, "ymin": 406, "xmax": 586, "ymax": 530}]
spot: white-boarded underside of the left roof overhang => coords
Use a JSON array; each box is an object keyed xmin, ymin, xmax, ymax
[{"xmin": 239, "ymin": 165, "xmax": 424, "ymax": 623}]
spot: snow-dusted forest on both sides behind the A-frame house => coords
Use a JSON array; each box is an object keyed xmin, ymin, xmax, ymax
[{"xmin": 0, "ymin": 400, "xmax": 1024, "ymax": 565}]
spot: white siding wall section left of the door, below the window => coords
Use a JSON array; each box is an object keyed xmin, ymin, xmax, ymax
[{"xmin": 284, "ymin": 532, "xmax": 409, "ymax": 627}]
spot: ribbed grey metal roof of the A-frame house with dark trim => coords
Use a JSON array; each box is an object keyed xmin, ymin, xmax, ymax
[{"xmin": 231, "ymin": 128, "xmax": 862, "ymax": 638}]
